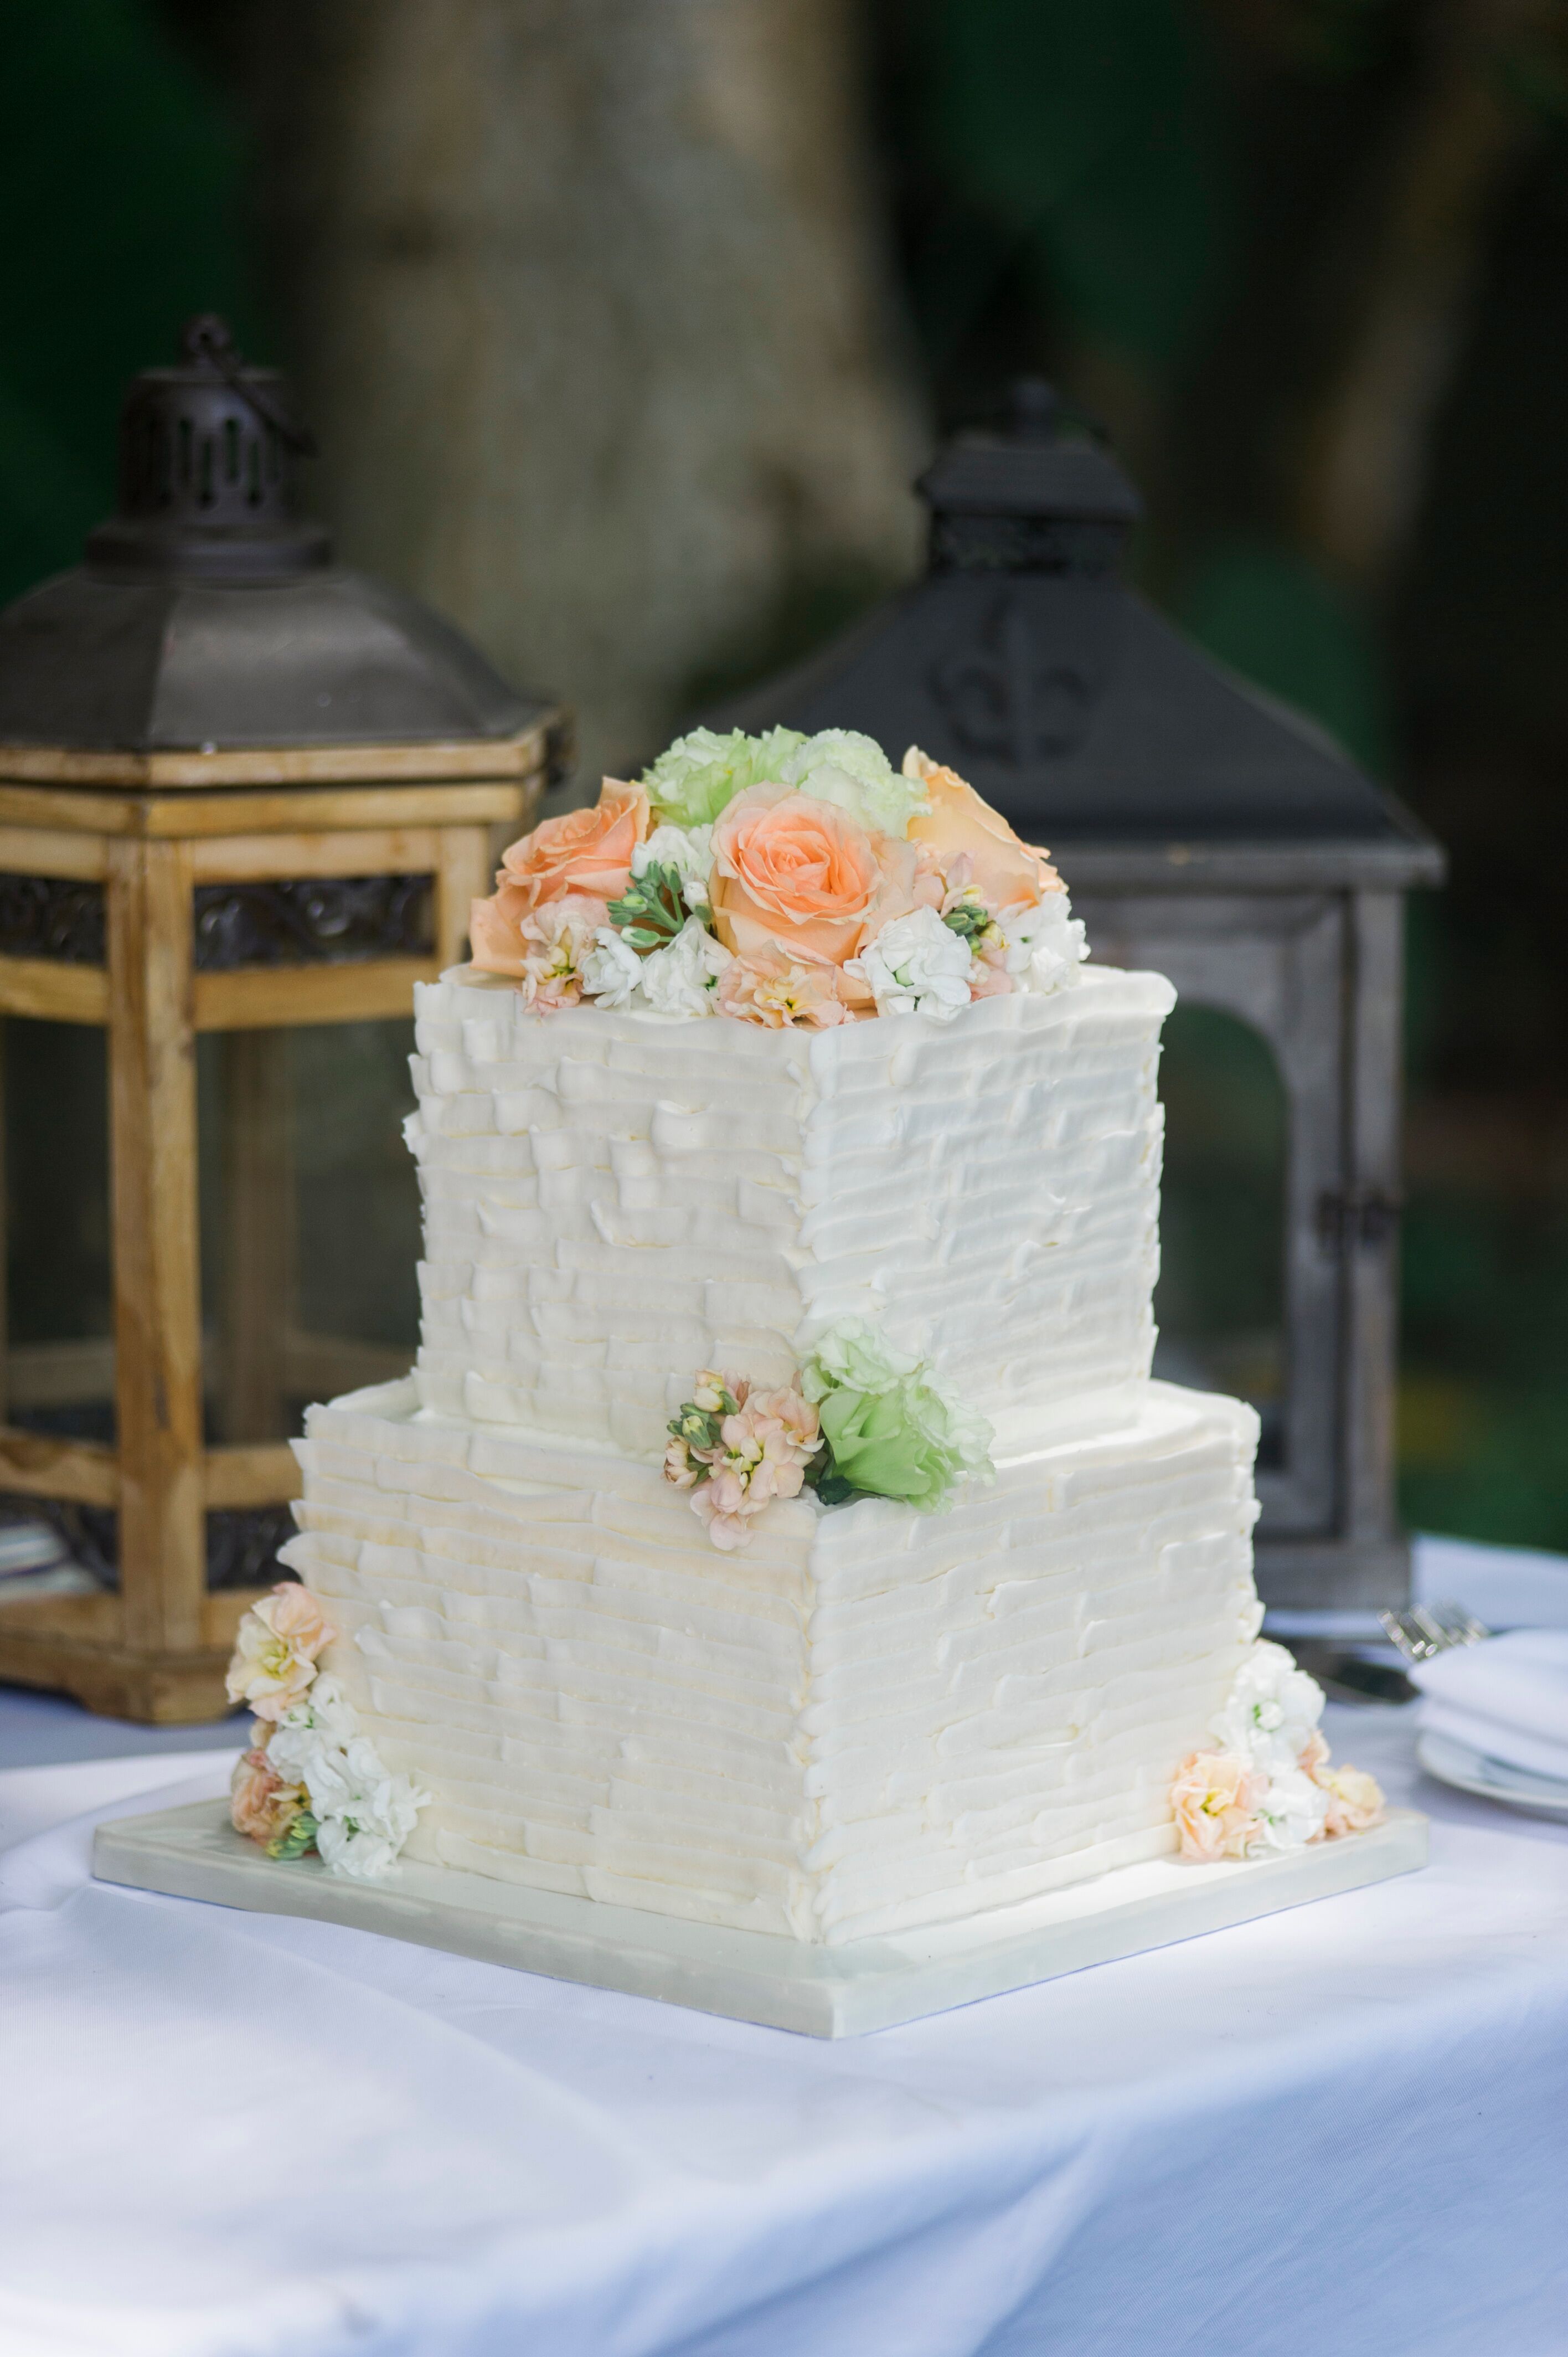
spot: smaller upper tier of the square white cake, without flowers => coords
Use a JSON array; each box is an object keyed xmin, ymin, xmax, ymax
[{"xmin": 408, "ymin": 966, "xmax": 1174, "ymax": 1454}]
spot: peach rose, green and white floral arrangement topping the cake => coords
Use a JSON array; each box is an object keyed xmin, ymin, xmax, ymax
[{"xmin": 469, "ymin": 728, "xmax": 1089, "ymax": 1030}]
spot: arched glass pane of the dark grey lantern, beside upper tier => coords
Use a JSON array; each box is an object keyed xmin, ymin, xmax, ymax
[{"xmin": 1156, "ymin": 1006, "xmax": 1287, "ymax": 1471}]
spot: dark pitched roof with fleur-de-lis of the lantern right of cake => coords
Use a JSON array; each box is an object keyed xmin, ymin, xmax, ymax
[{"xmin": 708, "ymin": 389, "xmax": 1441, "ymax": 882}]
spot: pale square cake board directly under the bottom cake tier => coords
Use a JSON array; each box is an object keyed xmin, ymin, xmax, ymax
[{"xmin": 92, "ymin": 1801, "xmax": 1426, "ymax": 2039}]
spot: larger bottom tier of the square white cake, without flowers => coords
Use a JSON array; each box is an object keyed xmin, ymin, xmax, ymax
[{"xmin": 288, "ymin": 1383, "xmax": 1261, "ymax": 1944}]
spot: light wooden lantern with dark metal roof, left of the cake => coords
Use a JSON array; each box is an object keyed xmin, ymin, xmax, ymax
[{"xmin": 0, "ymin": 321, "xmax": 559, "ymax": 1721}]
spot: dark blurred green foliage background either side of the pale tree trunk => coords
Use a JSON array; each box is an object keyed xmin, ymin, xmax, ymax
[{"xmin": 0, "ymin": 0, "xmax": 1568, "ymax": 1546}]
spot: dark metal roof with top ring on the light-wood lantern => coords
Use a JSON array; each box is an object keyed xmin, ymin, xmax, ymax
[{"xmin": 0, "ymin": 316, "xmax": 549, "ymax": 754}]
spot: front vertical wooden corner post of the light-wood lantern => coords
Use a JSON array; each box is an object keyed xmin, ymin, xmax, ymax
[{"xmin": 109, "ymin": 841, "xmax": 207, "ymax": 1669}]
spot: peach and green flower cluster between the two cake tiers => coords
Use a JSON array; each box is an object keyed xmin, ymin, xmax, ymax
[{"xmin": 665, "ymin": 1318, "xmax": 995, "ymax": 1548}]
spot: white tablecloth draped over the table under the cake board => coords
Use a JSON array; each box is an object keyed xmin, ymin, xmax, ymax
[{"xmin": 0, "ymin": 1711, "xmax": 1568, "ymax": 2357}]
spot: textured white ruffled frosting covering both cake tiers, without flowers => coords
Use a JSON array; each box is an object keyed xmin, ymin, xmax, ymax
[{"xmin": 275, "ymin": 947, "xmax": 1259, "ymax": 1942}]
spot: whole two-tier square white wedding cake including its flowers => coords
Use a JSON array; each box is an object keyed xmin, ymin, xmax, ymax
[{"xmin": 231, "ymin": 733, "xmax": 1375, "ymax": 1944}]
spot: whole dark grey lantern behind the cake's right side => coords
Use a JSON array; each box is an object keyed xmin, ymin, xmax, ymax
[{"xmin": 710, "ymin": 384, "xmax": 1443, "ymax": 1608}]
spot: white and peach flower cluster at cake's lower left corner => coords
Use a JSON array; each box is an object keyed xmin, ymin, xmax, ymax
[{"xmin": 229, "ymin": 1579, "xmax": 429, "ymax": 1881}]
